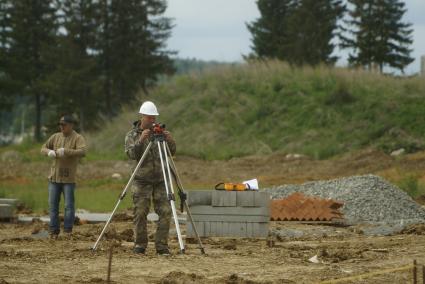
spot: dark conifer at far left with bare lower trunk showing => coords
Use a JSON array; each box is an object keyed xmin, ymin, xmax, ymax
[{"xmin": 7, "ymin": 0, "xmax": 58, "ymax": 141}]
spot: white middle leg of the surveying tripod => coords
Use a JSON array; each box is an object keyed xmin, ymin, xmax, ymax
[{"xmin": 157, "ymin": 141, "xmax": 185, "ymax": 253}]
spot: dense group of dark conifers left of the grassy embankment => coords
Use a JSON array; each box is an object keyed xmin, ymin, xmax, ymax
[{"xmin": 0, "ymin": 0, "xmax": 174, "ymax": 140}]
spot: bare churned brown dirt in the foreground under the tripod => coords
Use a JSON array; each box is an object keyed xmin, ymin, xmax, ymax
[{"xmin": 0, "ymin": 221, "xmax": 425, "ymax": 283}]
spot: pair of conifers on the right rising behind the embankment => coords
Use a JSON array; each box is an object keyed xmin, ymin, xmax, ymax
[{"xmin": 247, "ymin": 0, "xmax": 413, "ymax": 72}]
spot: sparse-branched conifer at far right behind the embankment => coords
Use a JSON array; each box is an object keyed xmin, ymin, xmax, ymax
[{"xmin": 341, "ymin": 0, "xmax": 413, "ymax": 72}]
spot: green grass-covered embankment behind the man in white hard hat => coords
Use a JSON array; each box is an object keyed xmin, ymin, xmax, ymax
[{"xmin": 89, "ymin": 62, "xmax": 425, "ymax": 159}]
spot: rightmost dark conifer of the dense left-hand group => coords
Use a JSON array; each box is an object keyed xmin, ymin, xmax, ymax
[{"xmin": 97, "ymin": 0, "xmax": 174, "ymax": 113}]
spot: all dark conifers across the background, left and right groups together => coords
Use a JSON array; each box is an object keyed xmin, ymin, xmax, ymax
[{"xmin": 0, "ymin": 0, "xmax": 413, "ymax": 140}]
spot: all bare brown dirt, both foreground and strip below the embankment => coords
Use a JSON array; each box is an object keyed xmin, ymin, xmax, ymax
[{"xmin": 0, "ymin": 150, "xmax": 425, "ymax": 284}]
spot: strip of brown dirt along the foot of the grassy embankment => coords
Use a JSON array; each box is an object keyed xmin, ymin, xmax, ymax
[{"xmin": 0, "ymin": 149, "xmax": 425, "ymax": 189}]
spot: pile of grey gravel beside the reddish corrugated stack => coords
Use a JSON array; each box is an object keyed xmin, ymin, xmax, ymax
[{"xmin": 265, "ymin": 175, "xmax": 425, "ymax": 223}]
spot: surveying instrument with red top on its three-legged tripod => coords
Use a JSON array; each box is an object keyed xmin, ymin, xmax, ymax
[{"xmin": 92, "ymin": 123, "xmax": 205, "ymax": 254}]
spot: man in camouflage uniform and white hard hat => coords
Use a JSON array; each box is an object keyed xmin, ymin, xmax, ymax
[{"xmin": 125, "ymin": 101, "xmax": 176, "ymax": 255}]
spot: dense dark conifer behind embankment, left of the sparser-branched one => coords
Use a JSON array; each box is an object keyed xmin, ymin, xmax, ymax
[{"xmin": 247, "ymin": 0, "xmax": 344, "ymax": 65}]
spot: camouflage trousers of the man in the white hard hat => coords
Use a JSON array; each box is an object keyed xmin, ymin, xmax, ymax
[{"xmin": 132, "ymin": 181, "xmax": 171, "ymax": 250}]
